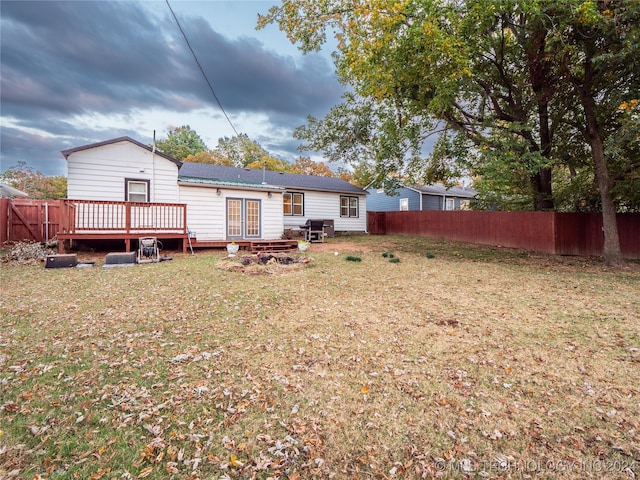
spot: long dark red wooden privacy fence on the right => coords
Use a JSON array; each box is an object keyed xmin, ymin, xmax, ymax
[{"xmin": 367, "ymin": 210, "xmax": 640, "ymax": 258}]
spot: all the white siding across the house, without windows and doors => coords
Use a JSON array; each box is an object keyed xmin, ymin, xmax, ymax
[{"xmin": 67, "ymin": 140, "xmax": 367, "ymax": 236}]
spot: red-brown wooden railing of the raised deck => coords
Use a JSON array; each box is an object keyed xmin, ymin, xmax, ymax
[{"xmin": 61, "ymin": 200, "xmax": 187, "ymax": 235}]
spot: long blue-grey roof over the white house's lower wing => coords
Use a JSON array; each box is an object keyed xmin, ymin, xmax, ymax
[{"xmin": 178, "ymin": 162, "xmax": 367, "ymax": 195}]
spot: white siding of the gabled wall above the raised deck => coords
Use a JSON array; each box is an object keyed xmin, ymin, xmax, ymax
[{"xmin": 67, "ymin": 141, "xmax": 178, "ymax": 203}]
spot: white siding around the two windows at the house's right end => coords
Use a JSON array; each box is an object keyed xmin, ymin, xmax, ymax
[{"xmin": 284, "ymin": 190, "xmax": 367, "ymax": 232}]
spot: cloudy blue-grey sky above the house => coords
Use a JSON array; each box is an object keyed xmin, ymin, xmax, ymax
[{"xmin": 0, "ymin": 0, "xmax": 343, "ymax": 175}]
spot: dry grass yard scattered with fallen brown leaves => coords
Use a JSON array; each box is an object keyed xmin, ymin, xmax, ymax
[{"xmin": 0, "ymin": 237, "xmax": 640, "ymax": 480}]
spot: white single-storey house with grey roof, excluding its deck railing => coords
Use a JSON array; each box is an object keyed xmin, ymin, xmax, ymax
[{"xmin": 62, "ymin": 137, "xmax": 367, "ymax": 241}]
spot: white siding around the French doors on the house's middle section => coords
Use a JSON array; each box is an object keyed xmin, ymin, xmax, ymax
[{"xmin": 180, "ymin": 185, "xmax": 284, "ymax": 241}]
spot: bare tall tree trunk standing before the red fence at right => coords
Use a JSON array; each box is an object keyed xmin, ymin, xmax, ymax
[{"xmin": 578, "ymin": 67, "xmax": 623, "ymax": 266}]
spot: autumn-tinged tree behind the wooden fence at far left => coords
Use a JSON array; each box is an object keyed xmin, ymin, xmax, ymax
[{"xmin": 0, "ymin": 161, "xmax": 67, "ymax": 200}]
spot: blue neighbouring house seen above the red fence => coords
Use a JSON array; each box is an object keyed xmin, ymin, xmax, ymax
[{"xmin": 367, "ymin": 184, "xmax": 477, "ymax": 212}]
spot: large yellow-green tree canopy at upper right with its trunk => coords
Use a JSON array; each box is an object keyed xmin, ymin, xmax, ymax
[{"xmin": 259, "ymin": 0, "xmax": 640, "ymax": 263}]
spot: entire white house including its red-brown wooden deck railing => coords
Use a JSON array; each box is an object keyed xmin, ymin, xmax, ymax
[{"xmin": 59, "ymin": 137, "xmax": 367, "ymax": 249}]
